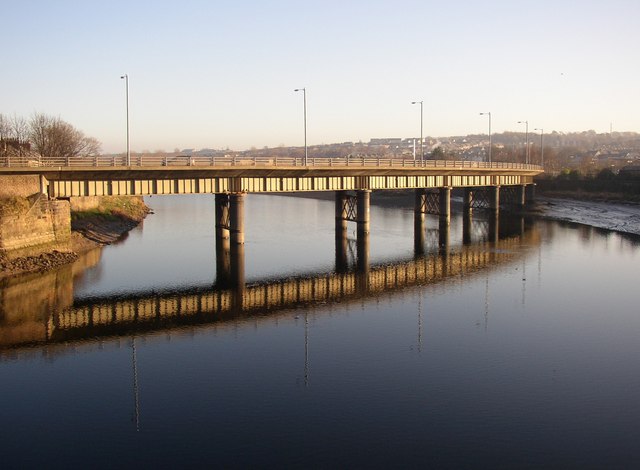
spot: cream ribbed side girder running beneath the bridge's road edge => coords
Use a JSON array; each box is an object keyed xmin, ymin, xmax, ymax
[{"xmin": 43, "ymin": 174, "xmax": 533, "ymax": 198}]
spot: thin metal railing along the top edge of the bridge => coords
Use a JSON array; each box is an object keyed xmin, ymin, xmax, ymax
[{"xmin": 0, "ymin": 155, "xmax": 540, "ymax": 169}]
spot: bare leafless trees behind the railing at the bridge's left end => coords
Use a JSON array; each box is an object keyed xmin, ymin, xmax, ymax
[{"xmin": 0, "ymin": 113, "xmax": 101, "ymax": 159}]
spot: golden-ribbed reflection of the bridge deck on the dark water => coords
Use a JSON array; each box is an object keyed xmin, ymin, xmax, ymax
[{"xmin": 4, "ymin": 213, "xmax": 539, "ymax": 347}]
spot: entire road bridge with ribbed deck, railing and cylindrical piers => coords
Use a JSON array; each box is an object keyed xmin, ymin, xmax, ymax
[{"xmin": 0, "ymin": 156, "xmax": 543, "ymax": 245}]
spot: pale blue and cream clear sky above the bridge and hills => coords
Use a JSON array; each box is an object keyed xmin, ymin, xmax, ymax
[{"xmin": 0, "ymin": 0, "xmax": 640, "ymax": 153}]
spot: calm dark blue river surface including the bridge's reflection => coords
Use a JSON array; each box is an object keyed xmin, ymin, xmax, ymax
[{"xmin": 0, "ymin": 196, "xmax": 640, "ymax": 468}]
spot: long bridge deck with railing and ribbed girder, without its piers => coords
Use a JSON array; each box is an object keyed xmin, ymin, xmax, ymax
[{"xmin": 0, "ymin": 157, "xmax": 543, "ymax": 197}]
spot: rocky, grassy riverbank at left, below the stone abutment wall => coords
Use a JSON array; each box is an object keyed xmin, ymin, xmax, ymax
[{"xmin": 0, "ymin": 197, "xmax": 150, "ymax": 279}]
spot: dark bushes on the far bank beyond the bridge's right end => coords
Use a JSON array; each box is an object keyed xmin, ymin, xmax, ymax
[{"xmin": 535, "ymin": 168, "xmax": 640, "ymax": 203}]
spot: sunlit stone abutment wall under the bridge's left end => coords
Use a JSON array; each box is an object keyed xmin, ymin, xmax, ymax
[{"xmin": 0, "ymin": 195, "xmax": 71, "ymax": 254}]
